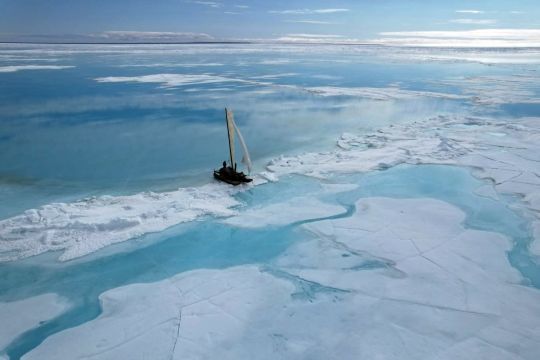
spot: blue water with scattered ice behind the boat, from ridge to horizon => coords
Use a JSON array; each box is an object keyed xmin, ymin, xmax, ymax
[{"xmin": 0, "ymin": 45, "xmax": 539, "ymax": 218}]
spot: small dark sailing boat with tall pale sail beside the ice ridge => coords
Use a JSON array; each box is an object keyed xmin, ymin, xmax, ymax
[{"xmin": 214, "ymin": 108, "xmax": 253, "ymax": 186}]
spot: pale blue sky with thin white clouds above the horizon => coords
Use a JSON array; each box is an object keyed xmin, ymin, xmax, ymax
[{"xmin": 0, "ymin": 0, "xmax": 540, "ymax": 44}]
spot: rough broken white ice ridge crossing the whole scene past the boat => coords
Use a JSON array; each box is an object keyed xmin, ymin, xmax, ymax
[{"xmin": 4, "ymin": 111, "xmax": 540, "ymax": 261}]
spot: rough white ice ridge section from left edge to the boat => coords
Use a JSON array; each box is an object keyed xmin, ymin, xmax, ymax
[{"xmin": 0, "ymin": 183, "xmax": 239, "ymax": 261}]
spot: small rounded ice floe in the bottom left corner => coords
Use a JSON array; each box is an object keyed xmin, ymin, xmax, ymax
[{"xmin": 0, "ymin": 294, "xmax": 69, "ymax": 350}]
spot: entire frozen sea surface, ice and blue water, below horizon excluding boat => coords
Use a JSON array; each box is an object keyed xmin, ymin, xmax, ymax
[{"xmin": 0, "ymin": 44, "xmax": 540, "ymax": 359}]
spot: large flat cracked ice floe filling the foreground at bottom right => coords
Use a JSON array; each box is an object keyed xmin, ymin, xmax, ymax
[{"xmin": 23, "ymin": 198, "xmax": 540, "ymax": 360}]
